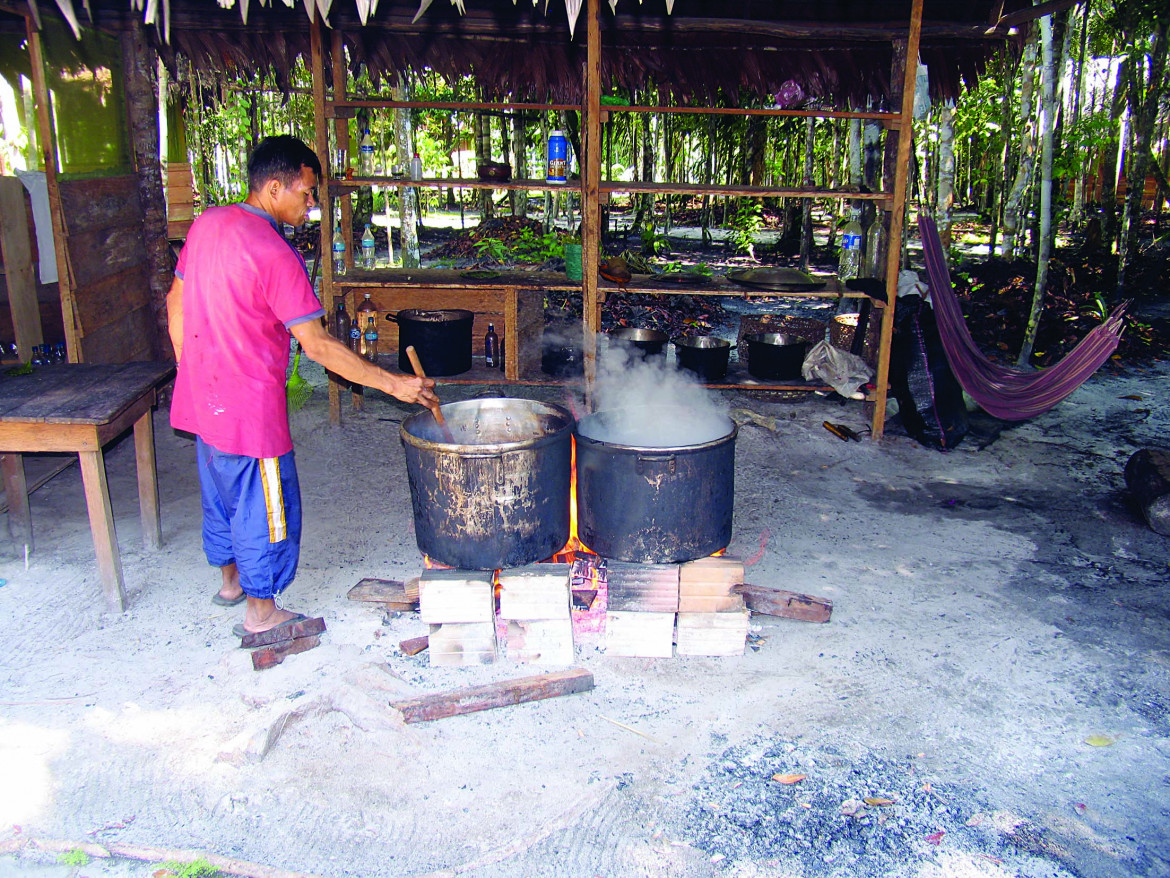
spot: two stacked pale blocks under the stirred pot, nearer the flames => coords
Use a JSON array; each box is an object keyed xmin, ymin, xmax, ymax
[{"xmin": 498, "ymin": 564, "xmax": 573, "ymax": 665}]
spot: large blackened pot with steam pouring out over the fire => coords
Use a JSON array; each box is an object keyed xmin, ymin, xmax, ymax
[{"xmin": 573, "ymin": 406, "xmax": 738, "ymax": 564}]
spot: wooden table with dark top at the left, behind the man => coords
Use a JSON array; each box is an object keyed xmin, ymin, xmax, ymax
[{"xmin": 0, "ymin": 363, "xmax": 174, "ymax": 611}]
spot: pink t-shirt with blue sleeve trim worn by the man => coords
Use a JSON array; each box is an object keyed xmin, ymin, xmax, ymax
[{"xmin": 171, "ymin": 204, "xmax": 325, "ymax": 458}]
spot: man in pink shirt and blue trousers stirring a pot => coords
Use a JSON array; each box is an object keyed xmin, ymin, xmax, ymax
[{"xmin": 166, "ymin": 135, "xmax": 439, "ymax": 632}]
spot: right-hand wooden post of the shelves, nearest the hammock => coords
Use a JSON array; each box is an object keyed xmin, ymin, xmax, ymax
[{"xmin": 870, "ymin": 0, "xmax": 922, "ymax": 439}]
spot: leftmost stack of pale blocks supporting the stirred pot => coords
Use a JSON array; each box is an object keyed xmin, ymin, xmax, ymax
[{"xmin": 419, "ymin": 570, "xmax": 496, "ymax": 666}]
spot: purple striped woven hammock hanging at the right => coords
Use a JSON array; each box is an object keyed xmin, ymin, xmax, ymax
[{"xmin": 918, "ymin": 217, "xmax": 1126, "ymax": 420}]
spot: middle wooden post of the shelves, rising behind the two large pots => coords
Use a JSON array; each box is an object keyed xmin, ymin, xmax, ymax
[{"xmin": 581, "ymin": 0, "xmax": 601, "ymax": 407}]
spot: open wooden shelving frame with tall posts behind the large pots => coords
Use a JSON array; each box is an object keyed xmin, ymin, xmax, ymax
[{"xmin": 310, "ymin": 0, "xmax": 923, "ymax": 439}]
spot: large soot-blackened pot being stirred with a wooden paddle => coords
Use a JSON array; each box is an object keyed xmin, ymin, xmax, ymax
[{"xmin": 400, "ymin": 399, "xmax": 573, "ymax": 570}]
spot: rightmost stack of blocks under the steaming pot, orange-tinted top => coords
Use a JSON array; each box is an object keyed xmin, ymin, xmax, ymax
[{"xmin": 675, "ymin": 557, "xmax": 750, "ymax": 656}]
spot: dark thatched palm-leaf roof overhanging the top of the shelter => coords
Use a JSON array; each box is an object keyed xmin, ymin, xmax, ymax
[{"xmin": 0, "ymin": 0, "xmax": 1073, "ymax": 107}]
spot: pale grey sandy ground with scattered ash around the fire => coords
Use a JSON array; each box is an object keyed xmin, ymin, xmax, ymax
[{"xmin": 0, "ymin": 353, "xmax": 1170, "ymax": 878}]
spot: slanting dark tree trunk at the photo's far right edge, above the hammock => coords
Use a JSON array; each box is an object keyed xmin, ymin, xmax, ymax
[{"xmin": 1117, "ymin": 20, "xmax": 1166, "ymax": 296}]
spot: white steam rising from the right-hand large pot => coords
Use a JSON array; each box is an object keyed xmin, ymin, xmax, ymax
[{"xmin": 580, "ymin": 337, "xmax": 731, "ymax": 448}]
